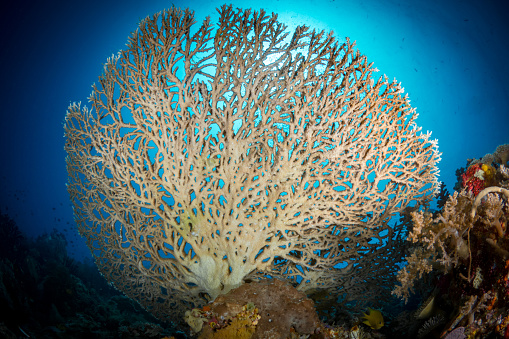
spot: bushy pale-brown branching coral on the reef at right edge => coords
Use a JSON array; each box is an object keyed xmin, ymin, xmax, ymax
[{"xmin": 393, "ymin": 187, "xmax": 509, "ymax": 300}]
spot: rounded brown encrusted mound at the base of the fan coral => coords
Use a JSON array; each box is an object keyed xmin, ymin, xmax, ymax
[{"xmin": 189, "ymin": 279, "xmax": 320, "ymax": 339}]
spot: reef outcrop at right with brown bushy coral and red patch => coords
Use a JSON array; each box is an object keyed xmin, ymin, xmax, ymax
[{"xmin": 393, "ymin": 148, "xmax": 509, "ymax": 338}]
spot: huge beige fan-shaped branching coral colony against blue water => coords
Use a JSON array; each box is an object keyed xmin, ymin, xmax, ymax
[{"xmin": 65, "ymin": 6, "xmax": 440, "ymax": 319}]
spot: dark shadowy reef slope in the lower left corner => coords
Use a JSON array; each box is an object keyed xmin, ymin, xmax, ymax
[{"xmin": 0, "ymin": 213, "xmax": 185, "ymax": 339}]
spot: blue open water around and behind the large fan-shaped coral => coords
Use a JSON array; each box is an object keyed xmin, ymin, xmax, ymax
[{"xmin": 0, "ymin": 0, "xmax": 509, "ymax": 337}]
